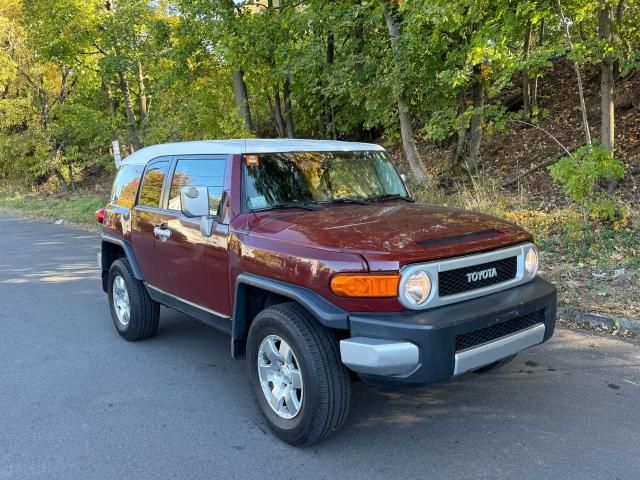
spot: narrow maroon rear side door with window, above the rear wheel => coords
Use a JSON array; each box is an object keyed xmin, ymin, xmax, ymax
[{"xmin": 131, "ymin": 157, "xmax": 171, "ymax": 285}]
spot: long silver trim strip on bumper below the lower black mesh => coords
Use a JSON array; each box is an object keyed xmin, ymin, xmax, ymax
[{"xmin": 453, "ymin": 324, "xmax": 544, "ymax": 375}]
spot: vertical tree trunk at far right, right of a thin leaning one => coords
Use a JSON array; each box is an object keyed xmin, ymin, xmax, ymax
[{"xmin": 598, "ymin": 4, "xmax": 615, "ymax": 154}]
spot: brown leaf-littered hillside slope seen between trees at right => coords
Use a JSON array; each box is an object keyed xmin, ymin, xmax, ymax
[{"xmin": 391, "ymin": 60, "xmax": 640, "ymax": 203}]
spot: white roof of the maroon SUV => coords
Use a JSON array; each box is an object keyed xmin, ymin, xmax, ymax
[{"xmin": 122, "ymin": 138, "xmax": 384, "ymax": 164}]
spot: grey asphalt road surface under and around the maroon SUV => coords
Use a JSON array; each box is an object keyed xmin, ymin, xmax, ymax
[{"xmin": 0, "ymin": 215, "xmax": 640, "ymax": 480}]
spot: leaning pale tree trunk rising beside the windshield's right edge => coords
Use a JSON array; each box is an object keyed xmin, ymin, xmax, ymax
[{"xmin": 381, "ymin": 0, "xmax": 426, "ymax": 182}]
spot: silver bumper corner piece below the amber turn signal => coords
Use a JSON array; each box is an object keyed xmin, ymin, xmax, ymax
[{"xmin": 340, "ymin": 337, "xmax": 420, "ymax": 375}]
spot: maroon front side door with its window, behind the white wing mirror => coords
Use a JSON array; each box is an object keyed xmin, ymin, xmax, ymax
[{"xmin": 154, "ymin": 156, "xmax": 231, "ymax": 316}]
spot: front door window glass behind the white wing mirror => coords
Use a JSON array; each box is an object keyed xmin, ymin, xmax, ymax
[{"xmin": 169, "ymin": 159, "xmax": 226, "ymax": 215}]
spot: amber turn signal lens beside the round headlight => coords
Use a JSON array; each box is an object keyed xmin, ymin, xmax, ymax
[{"xmin": 331, "ymin": 273, "xmax": 400, "ymax": 298}]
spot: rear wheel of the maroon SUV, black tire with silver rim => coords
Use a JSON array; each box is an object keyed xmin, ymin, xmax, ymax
[{"xmin": 107, "ymin": 258, "xmax": 160, "ymax": 341}]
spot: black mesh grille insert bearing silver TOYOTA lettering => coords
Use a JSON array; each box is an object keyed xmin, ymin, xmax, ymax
[{"xmin": 438, "ymin": 257, "xmax": 518, "ymax": 297}]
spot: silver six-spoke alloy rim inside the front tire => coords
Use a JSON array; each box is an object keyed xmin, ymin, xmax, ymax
[{"xmin": 258, "ymin": 335, "xmax": 304, "ymax": 419}]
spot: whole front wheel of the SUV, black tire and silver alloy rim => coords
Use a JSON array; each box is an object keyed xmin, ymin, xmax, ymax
[{"xmin": 247, "ymin": 302, "xmax": 351, "ymax": 446}]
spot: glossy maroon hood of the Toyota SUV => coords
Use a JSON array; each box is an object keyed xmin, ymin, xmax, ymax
[{"xmin": 248, "ymin": 201, "xmax": 531, "ymax": 270}]
